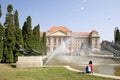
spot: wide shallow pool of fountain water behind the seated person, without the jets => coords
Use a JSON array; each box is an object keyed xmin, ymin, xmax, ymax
[{"xmin": 46, "ymin": 55, "xmax": 120, "ymax": 76}]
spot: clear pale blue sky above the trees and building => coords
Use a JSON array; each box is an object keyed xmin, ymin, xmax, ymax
[{"xmin": 0, "ymin": 0, "xmax": 120, "ymax": 41}]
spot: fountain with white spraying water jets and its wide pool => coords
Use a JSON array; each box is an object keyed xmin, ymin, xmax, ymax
[{"xmin": 44, "ymin": 37, "xmax": 120, "ymax": 76}]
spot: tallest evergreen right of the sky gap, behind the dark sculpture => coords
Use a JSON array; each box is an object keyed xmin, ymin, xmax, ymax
[{"xmin": 22, "ymin": 16, "xmax": 33, "ymax": 49}]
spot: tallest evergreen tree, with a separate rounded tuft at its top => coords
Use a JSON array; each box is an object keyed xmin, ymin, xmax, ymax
[{"xmin": 2, "ymin": 4, "xmax": 15, "ymax": 63}]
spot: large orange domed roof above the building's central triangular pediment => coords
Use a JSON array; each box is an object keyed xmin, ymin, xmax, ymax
[{"xmin": 48, "ymin": 26, "xmax": 72, "ymax": 32}]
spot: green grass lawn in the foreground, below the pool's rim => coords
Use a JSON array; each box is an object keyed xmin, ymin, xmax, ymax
[{"xmin": 0, "ymin": 64, "xmax": 116, "ymax": 80}]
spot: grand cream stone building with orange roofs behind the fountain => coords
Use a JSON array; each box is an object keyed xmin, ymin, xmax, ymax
[{"xmin": 41, "ymin": 26, "xmax": 100, "ymax": 52}]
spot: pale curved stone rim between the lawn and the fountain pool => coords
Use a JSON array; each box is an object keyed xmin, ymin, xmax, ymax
[{"xmin": 64, "ymin": 66, "xmax": 120, "ymax": 80}]
